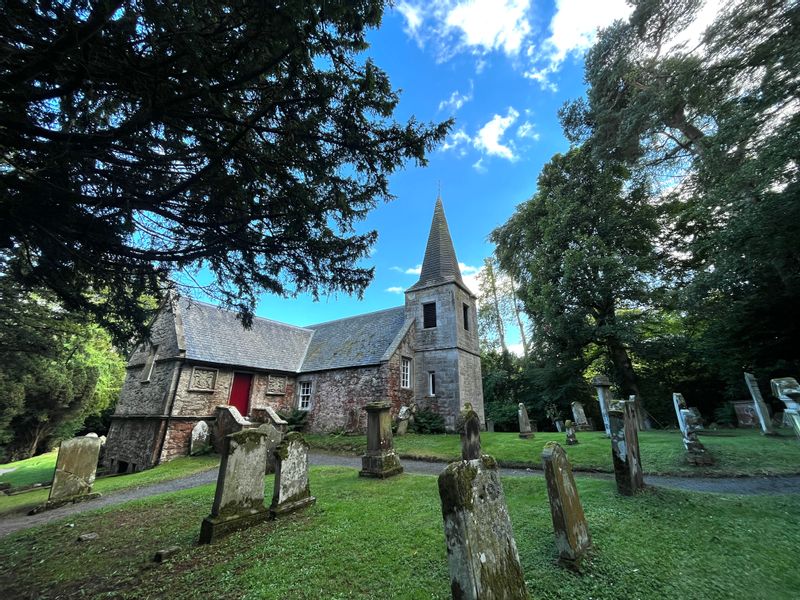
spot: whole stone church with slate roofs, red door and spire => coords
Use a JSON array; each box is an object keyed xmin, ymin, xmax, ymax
[{"xmin": 104, "ymin": 199, "xmax": 483, "ymax": 472}]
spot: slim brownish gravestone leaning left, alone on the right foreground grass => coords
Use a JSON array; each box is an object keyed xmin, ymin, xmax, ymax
[{"xmin": 542, "ymin": 442, "xmax": 592, "ymax": 569}]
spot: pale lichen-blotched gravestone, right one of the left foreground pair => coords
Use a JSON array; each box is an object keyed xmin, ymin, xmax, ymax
[{"xmin": 269, "ymin": 431, "xmax": 317, "ymax": 518}]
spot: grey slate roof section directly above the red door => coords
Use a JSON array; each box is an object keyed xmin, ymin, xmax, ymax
[{"xmin": 178, "ymin": 298, "xmax": 314, "ymax": 372}]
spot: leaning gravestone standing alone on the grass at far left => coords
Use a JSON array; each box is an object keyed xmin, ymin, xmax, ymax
[{"xmin": 31, "ymin": 434, "xmax": 100, "ymax": 513}]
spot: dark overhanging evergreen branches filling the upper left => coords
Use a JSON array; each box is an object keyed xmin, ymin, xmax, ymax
[{"xmin": 0, "ymin": 0, "xmax": 450, "ymax": 340}]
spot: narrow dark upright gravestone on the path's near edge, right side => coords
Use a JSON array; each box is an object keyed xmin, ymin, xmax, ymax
[{"xmin": 608, "ymin": 400, "xmax": 644, "ymax": 496}]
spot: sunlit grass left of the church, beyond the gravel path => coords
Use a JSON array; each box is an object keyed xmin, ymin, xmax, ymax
[{"xmin": 0, "ymin": 452, "xmax": 219, "ymax": 515}]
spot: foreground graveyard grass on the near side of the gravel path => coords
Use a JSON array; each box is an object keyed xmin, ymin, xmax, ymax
[{"xmin": 0, "ymin": 467, "xmax": 800, "ymax": 599}]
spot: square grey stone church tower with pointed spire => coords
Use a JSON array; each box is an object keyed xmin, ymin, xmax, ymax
[{"xmin": 405, "ymin": 197, "xmax": 484, "ymax": 431}]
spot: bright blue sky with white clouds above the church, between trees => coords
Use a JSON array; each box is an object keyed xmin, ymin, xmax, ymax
[{"xmin": 202, "ymin": 0, "xmax": 720, "ymax": 350}]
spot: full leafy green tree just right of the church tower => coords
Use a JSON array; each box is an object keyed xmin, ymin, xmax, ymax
[{"xmin": 491, "ymin": 148, "xmax": 658, "ymax": 424}]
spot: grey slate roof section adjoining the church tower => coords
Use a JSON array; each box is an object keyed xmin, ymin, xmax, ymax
[{"xmin": 301, "ymin": 306, "xmax": 406, "ymax": 372}]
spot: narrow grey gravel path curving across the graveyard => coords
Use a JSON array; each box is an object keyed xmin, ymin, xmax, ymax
[{"xmin": 0, "ymin": 452, "xmax": 800, "ymax": 537}]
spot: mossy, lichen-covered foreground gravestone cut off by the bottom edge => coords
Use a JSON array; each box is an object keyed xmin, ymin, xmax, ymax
[{"xmin": 439, "ymin": 455, "xmax": 528, "ymax": 600}]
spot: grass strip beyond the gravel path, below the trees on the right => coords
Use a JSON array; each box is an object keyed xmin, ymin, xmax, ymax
[{"xmin": 305, "ymin": 429, "xmax": 800, "ymax": 477}]
